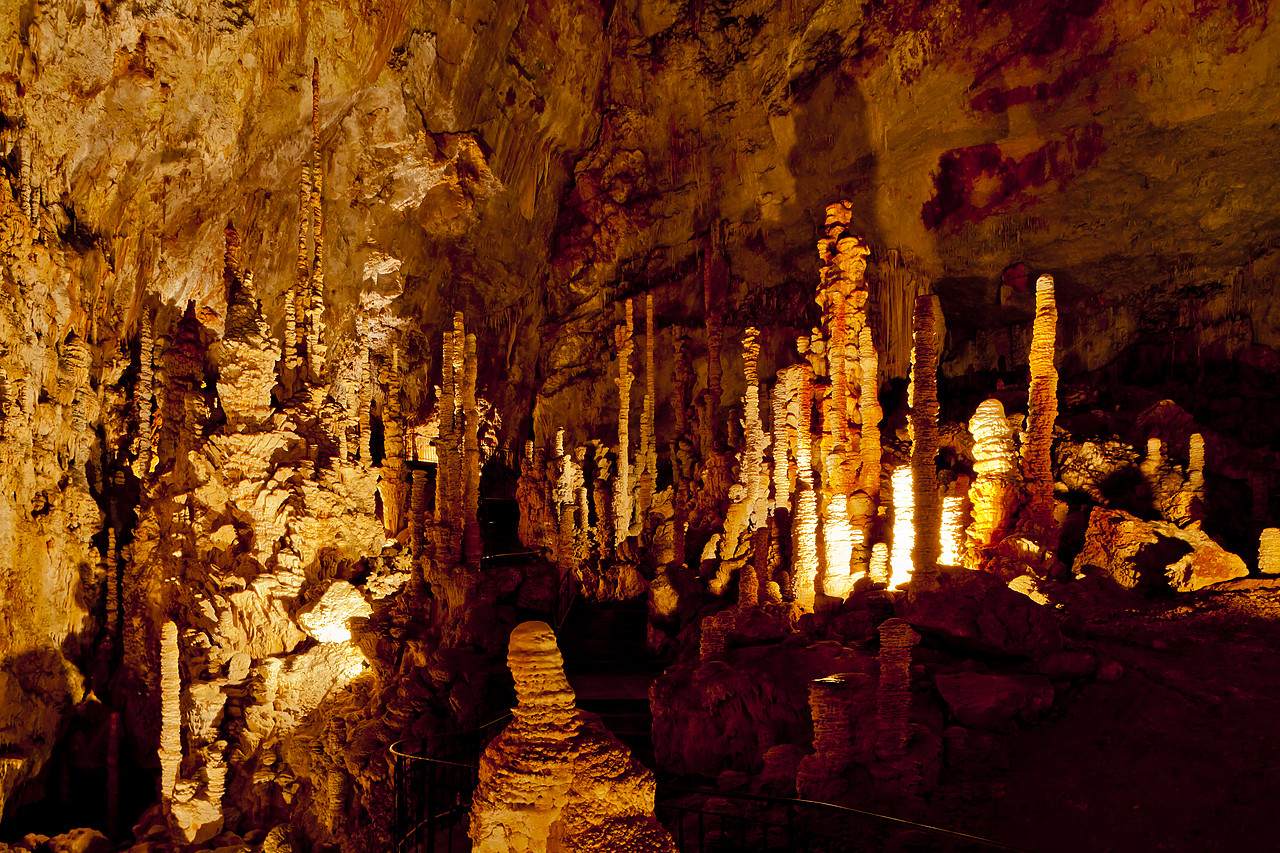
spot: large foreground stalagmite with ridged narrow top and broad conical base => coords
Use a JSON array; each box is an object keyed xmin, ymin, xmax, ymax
[{"xmin": 470, "ymin": 622, "xmax": 676, "ymax": 853}]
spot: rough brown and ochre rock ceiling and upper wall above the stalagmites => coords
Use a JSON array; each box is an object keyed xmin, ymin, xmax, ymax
[{"xmin": 0, "ymin": 0, "xmax": 1280, "ymax": 435}]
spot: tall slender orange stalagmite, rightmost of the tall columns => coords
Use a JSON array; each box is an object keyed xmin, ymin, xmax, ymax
[{"xmin": 1021, "ymin": 275, "xmax": 1059, "ymax": 563}]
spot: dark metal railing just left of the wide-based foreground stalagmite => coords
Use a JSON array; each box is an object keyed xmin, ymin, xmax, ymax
[{"xmin": 390, "ymin": 713, "xmax": 511, "ymax": 853}]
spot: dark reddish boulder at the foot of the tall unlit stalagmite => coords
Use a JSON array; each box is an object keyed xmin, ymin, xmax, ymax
[{"xmin": 902, "ymin": 566, "xmax": 1062, "ymax": 657}]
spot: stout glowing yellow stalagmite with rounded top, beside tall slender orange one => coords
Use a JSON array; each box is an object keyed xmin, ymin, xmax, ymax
[{"xmin": 964, "ymin": 400, "xmax": 1019, "ymax": 570}]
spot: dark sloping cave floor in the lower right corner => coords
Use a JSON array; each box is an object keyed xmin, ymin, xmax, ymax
[{"xmin": 940, "ymin": 589, "xmax": 1280, "ymax": 853}]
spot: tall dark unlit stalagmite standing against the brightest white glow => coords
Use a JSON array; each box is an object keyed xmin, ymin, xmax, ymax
[{"xmin": 908, "ymin": 295, "xmax": 942, "ymax": 589}]
